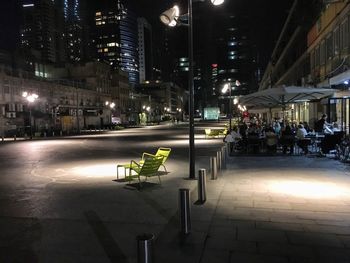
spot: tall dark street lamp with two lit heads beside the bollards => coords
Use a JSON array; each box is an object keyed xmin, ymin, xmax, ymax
[{"xmin": 159, "ymin": 0, "xmax": 225, "ymax": 179}]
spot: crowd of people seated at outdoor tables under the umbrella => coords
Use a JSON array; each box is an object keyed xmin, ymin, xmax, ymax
[{"xmin": 224, "ymin": 114, "xmax": 332, "ymax": 154}]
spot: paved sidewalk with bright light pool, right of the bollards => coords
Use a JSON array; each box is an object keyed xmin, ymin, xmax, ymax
[{"xmin": 156, "ymin": 156, "xmax": 350, "ymax": 263}]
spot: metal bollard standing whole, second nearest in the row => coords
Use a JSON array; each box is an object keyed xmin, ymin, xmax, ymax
[{"xmin": 179, "ymin": 188, "xmax": 191, "ymax": 235}]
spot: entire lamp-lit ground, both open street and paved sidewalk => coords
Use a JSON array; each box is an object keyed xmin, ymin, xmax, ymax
[{"xmin": 0, "ymin": 126, "xmax": 350, "ymax": 263}]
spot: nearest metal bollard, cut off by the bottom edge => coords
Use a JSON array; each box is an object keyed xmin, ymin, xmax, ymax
[{"xmin": 136, "ymin": 234, "xmax": 154, "ymax": 263}]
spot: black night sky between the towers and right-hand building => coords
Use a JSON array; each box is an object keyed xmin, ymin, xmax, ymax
[{"xmin": 127, "ymin": 0, "xmax": 294, "ymax": 70}]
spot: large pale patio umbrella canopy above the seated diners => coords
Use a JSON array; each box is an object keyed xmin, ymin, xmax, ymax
[{"xmin": 240, "ymin": 86, "xmax": 335, "ymax": 108}]
